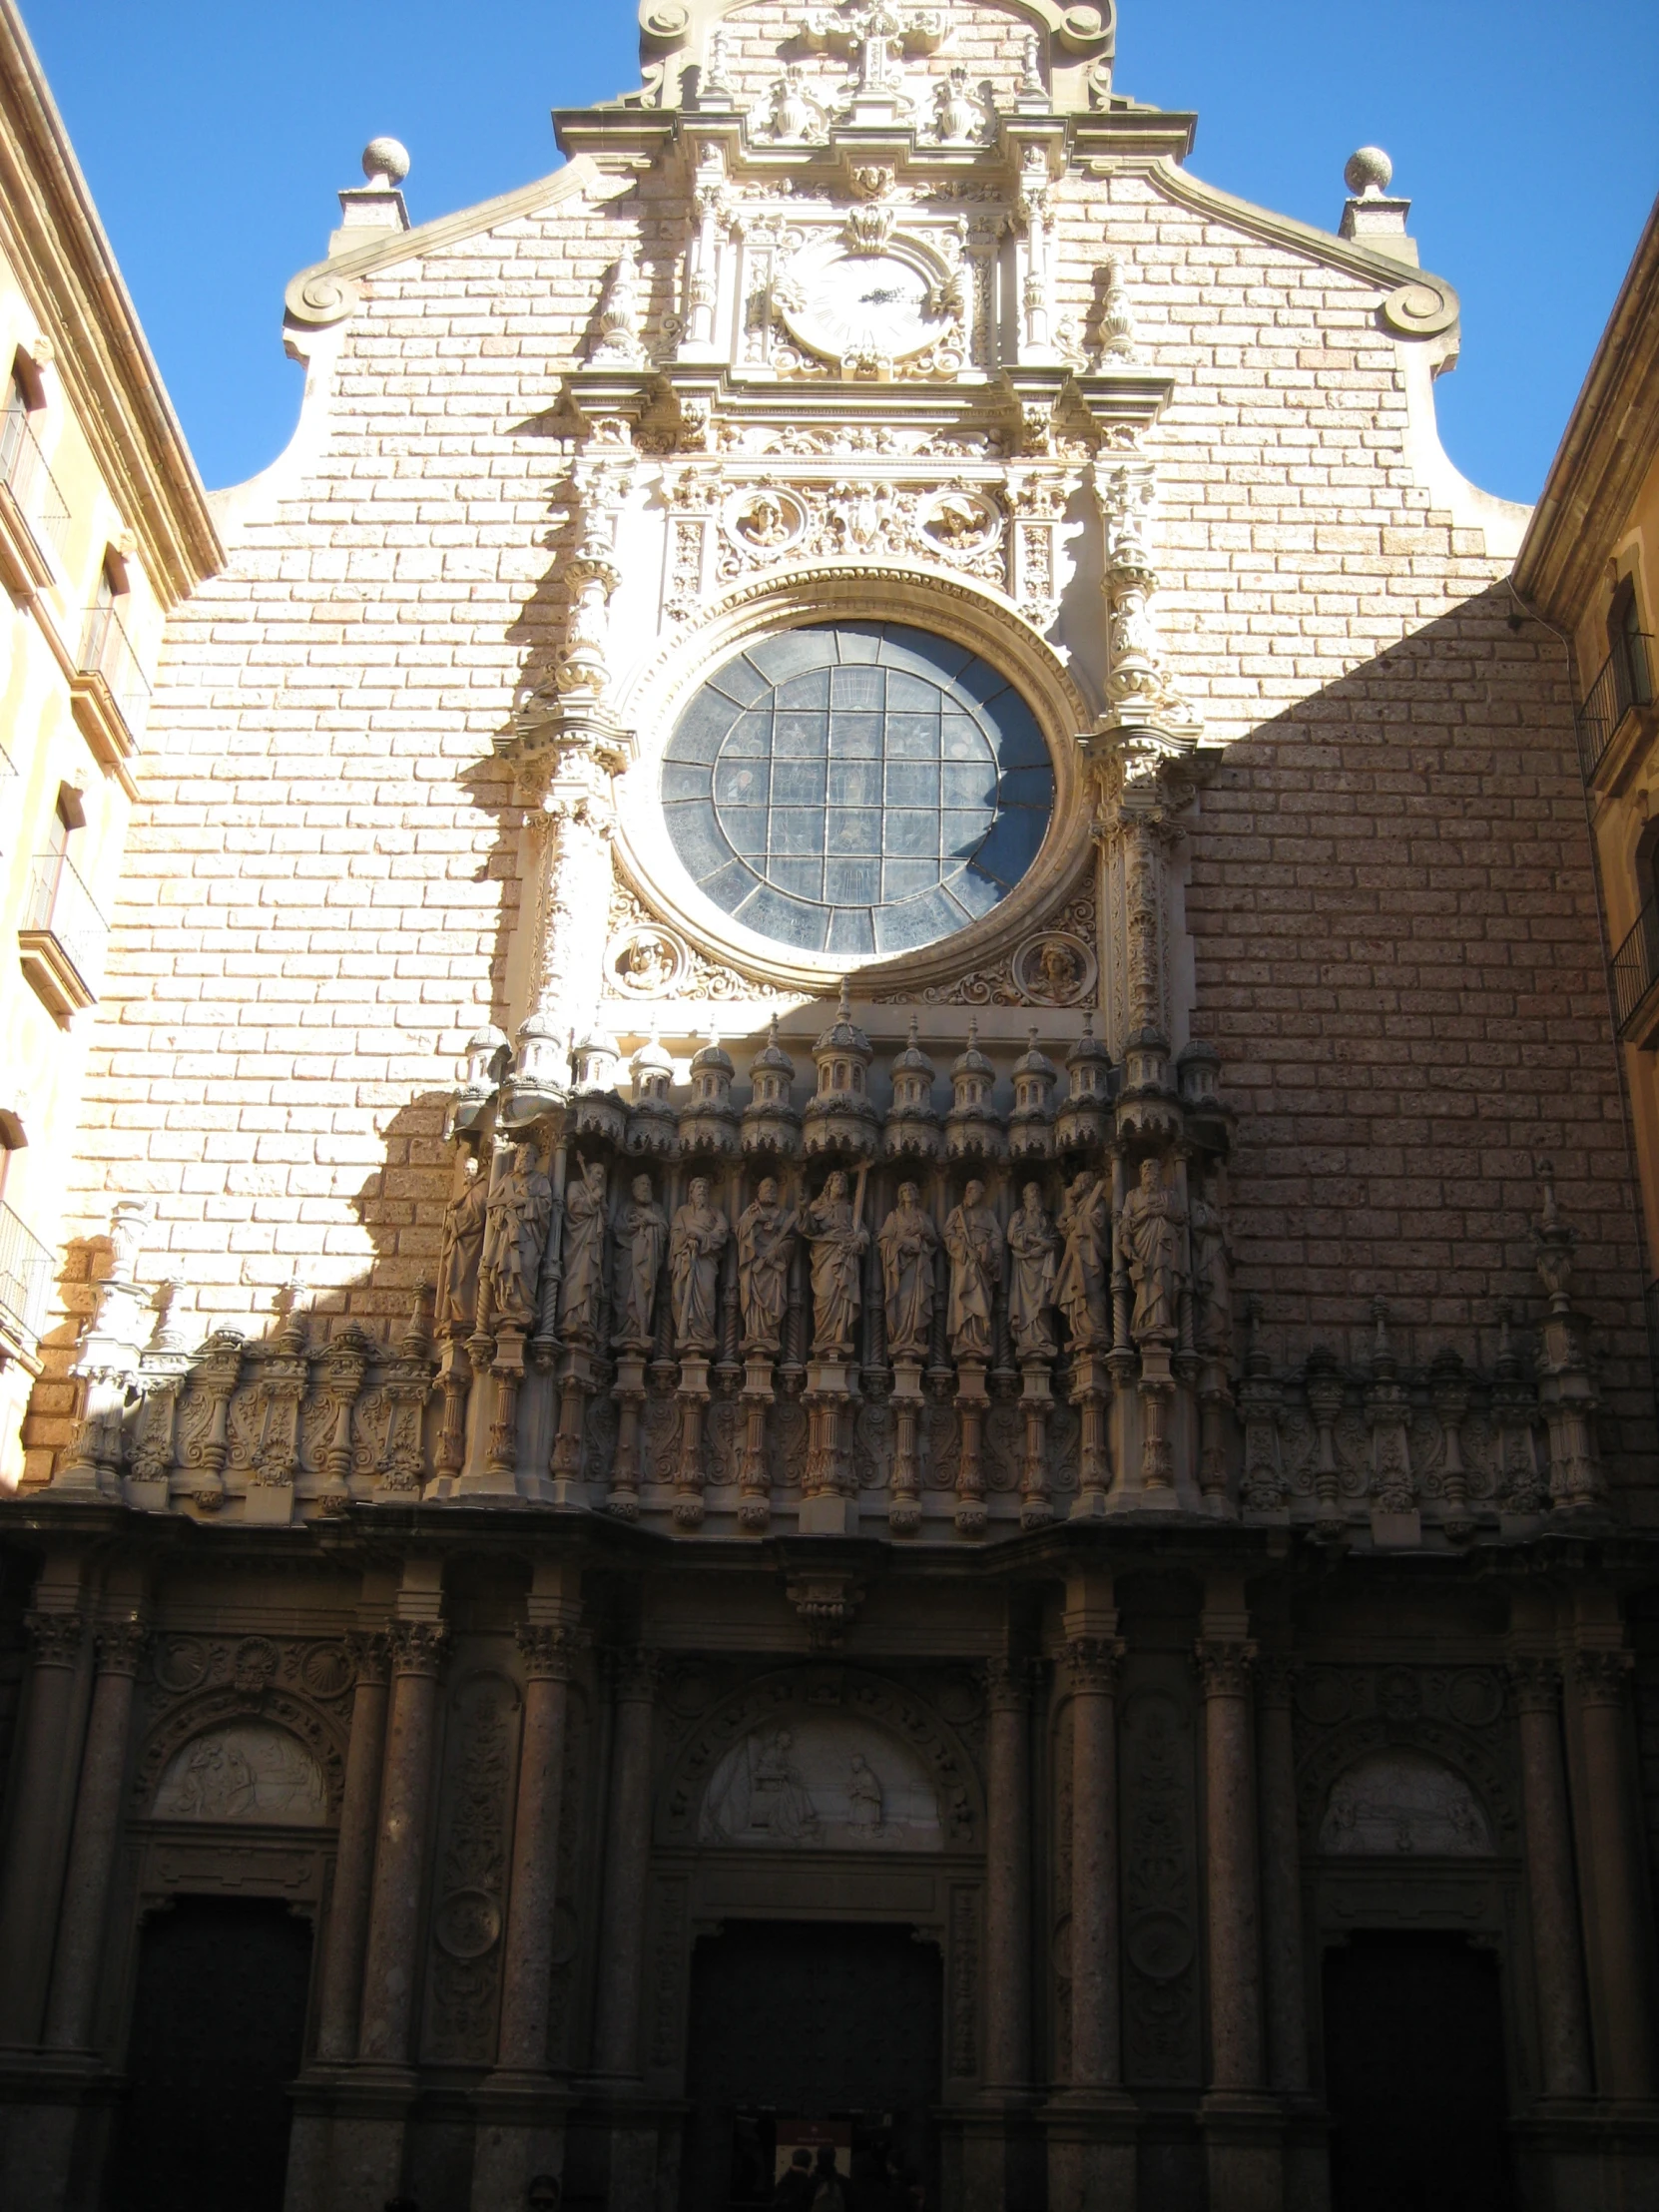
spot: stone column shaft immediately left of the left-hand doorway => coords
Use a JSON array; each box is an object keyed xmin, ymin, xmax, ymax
[{"xmin": 47, "ymin": 1612, "xmax": 146, "ymax": 2050}]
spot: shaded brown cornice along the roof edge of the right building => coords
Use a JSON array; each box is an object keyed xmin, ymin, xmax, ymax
[{"xmin": 1515, "ymin": 199, "xmax": 1659, "ymax": 631}]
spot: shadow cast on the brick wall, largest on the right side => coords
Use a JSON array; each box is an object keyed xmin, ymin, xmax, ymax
[{"xmin": 16, "ymin": 570, "xmax": 1655, "ymax": 1484}]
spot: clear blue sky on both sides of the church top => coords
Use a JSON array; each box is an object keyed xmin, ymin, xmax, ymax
[{"xmin": 22, "ymin": 0, "xmax": 1659, "ymax": 500}]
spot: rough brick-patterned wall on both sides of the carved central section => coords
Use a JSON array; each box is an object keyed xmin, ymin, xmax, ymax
[{"xmin": 29, "ymin": 99, "xmax": 1659, "ymax": 1513}]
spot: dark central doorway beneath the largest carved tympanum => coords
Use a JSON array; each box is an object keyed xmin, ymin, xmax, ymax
[{"xmin": 682, "ymin": 1920, "xmax": 942, "ymax": 2212}]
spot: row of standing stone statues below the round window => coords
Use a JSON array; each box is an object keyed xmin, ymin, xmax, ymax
[{"xmin": 438, "ymin": 1144, "xmax": 1232, "ymax": 1361}]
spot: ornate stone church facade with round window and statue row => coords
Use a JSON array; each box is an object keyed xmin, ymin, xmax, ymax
[{"xmin": 0, "ymin": 0, "xmax": 1659, "ymax": 2212}]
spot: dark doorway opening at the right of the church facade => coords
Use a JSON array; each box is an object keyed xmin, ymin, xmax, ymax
[{"xmin": 1325, "ymin": 1936, "xmax": 1515, "ymax": 2212}]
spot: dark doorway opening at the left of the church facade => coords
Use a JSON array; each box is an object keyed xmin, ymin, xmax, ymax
[{"xmin": 106, "ymin": 1898, "xmax": 311, "ymax": 2212}]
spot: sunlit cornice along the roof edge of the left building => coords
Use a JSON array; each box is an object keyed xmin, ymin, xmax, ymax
[{"xmin": 0, "ymin": 0, "xmax": 226, "ymax": 606}]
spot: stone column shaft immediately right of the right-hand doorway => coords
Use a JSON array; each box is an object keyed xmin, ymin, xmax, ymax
[{"xmin": 1508, "ymin": 1652, "xmax": 1593, "ymax": 2097}]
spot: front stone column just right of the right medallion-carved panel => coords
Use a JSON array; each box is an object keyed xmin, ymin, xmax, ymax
[{"xmin": 1197, "ymin": 1577, "xmax": 1283, "ymax": 2212}]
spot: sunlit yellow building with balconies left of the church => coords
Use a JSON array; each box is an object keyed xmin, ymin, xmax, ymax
[{"xmin": 0, "ymin": 4, "xmax": 222, "ymax": 1488}]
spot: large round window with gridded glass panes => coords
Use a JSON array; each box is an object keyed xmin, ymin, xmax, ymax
[{"xmin": 662, "ymin": 622, "xmax": 1055, "ymax": 958}]
